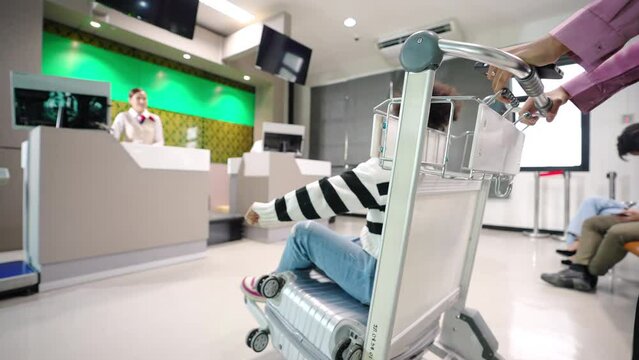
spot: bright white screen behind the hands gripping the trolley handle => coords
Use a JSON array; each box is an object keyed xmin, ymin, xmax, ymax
[{"xmin": 512, "ymin": 64, "xmax": 590, "ymax": 171}]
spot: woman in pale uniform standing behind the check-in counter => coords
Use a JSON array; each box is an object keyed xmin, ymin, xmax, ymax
[{"xmin": 111, "ymin": 88, "xmax": 164, "ymax": 146}]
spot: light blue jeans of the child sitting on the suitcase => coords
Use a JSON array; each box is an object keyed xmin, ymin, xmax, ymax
[{"xmin": 276, "ymin": 221, "xmax": 377, "ymax": 305}]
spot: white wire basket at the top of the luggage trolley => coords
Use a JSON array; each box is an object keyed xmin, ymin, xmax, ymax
[{"xmin": 370, "ymin": 89, "xmax": 525, "ymax": 197}]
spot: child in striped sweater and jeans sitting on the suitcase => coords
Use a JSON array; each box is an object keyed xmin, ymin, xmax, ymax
[{"xmin": 241, "ymin": 83, "xmax": 460, "ymax": 305}]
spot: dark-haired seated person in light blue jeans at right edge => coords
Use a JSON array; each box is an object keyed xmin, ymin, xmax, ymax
[{"xmin": 557, "ymin": 124, "xmax": 639, "ymax": 256}]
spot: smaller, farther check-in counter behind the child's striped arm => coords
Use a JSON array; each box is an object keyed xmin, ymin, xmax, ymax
[{"xmin": 228, "ymin": 152, "xmax": 331, "ymax": 241}]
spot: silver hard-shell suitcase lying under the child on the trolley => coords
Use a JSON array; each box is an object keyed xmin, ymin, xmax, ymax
[{"xmin": 265, "ymin": 271, "xmax": 368, "ymax": 360}]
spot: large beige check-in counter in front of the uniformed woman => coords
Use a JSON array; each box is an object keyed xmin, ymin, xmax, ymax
[{"xmin": 22, "ymin": 127, "xmax": 210, "ymax": 290}]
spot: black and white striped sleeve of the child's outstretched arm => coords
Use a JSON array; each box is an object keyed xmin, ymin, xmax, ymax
[{"xmin": 252, "ymin": 159, "xmax": 390, "ymax": 225}]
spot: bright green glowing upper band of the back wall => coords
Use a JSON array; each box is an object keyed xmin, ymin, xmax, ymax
[{"xmin": 42, "ymin": 32, "xmax": 255, "ymax": 126}]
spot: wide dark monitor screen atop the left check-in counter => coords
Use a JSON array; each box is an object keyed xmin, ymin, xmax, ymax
[{"xmin": 14, "ymin": 88, "xmax": 108, "ymax": 129}]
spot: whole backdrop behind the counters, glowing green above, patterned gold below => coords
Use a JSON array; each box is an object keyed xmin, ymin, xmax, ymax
[{"xmin": 42, "ymin": 27, "xmax": 255, "ymax": 162}]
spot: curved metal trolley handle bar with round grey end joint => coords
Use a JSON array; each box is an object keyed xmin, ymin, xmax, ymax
[{"xmin": 400, "ymin": 31, "xmax": 552, "ymax": 117}]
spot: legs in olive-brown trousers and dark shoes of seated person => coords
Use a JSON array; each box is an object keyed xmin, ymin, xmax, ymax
[{"xmin": 541, "ymin": 209, "xmax": 639, "ymax": 291}]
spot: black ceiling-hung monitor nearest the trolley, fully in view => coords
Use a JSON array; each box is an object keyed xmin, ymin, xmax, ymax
[{"xmin": 255, "ymin": 26, "xmax": 313, "ymax": 85}]
